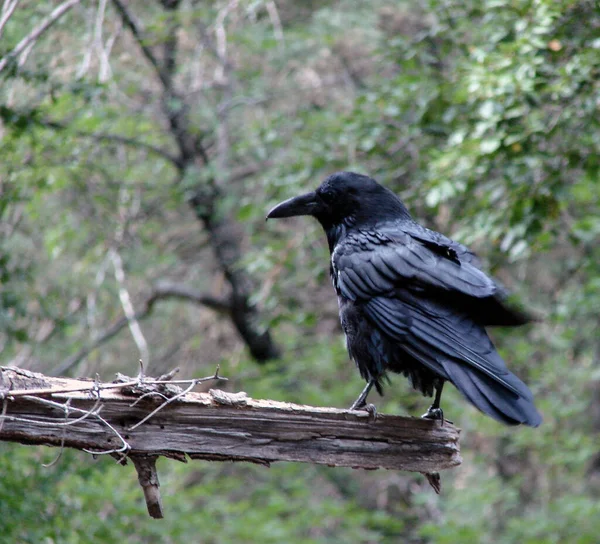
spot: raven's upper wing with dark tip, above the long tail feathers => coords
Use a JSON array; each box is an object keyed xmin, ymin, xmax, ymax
[{"xmin": 331, "ymin": 221, "xmax": 533, "ymax": 326}]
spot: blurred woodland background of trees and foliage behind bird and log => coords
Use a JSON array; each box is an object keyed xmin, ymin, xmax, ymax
[{"xmin": 0, "ymin": 0, "xmax": 600, "ymax": 544}]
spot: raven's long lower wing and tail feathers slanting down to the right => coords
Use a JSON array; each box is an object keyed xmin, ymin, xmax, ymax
[{"xmin": 363, "ymin": 289, "xmax": 542, "ymax": 427}]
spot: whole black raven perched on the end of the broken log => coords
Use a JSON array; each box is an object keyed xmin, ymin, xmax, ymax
[{"xmin": 267, "ymin": 172, "xmax": 542, "ymax": 427}]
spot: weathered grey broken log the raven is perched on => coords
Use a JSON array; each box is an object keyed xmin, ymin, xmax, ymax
[{"xmin": 0, "ymin": 368, "xmax": 461, "ymax": 474}]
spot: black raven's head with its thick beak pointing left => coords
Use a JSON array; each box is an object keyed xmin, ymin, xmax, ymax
[{"xmin": 267, "ymin": 172, "xmax": 410, "ymax": 232}]
